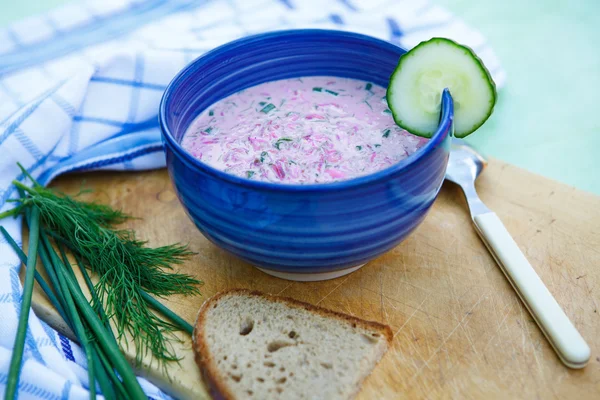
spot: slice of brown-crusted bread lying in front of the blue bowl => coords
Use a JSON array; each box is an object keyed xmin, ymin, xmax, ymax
[{"xmin": 193, "ymin": 289, "xmax": 392, "ymax": 400}]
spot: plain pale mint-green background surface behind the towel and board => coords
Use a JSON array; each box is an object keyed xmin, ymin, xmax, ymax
[{"xmin": 0, "ymin": 0, "xmax": 600, "ymax": 194}]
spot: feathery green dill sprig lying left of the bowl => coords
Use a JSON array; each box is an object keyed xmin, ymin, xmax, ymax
[{"xmin": 0, "ymin": 169, "xmax": 202, "ymax": 364}]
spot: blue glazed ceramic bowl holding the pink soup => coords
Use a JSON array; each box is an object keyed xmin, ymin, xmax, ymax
[{"xmin": 159, "ymin": 30, "xmax": 453, "ymax": 280}]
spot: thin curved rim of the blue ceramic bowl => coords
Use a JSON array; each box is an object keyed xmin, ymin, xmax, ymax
[{"xmin": 158, "ymin": 29, "xmax": 454, "ymax": 192}]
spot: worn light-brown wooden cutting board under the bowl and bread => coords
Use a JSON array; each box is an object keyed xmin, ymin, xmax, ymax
[{"xmin": 25, "ymin": 160, "xmax": 600, "ymax": 399}]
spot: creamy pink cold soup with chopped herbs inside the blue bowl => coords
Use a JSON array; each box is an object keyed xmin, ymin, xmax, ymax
[{"xmin": 181, "ymin": 77, "xmax": 427, "ymax": 184}]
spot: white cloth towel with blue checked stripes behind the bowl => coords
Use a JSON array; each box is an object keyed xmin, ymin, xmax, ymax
[{"xmin": 0, "ymin": 0, "xmax": 505, "ymax": 399}]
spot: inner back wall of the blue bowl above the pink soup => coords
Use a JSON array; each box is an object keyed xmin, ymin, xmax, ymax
[{"xmin": 164, "ymin": 30, "xmax": 405, "ymax": 143}]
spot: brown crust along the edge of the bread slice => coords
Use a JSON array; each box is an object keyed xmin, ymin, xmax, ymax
[{"xmin": 192, "ymin": 289, "xmax": 393, "ymax": 400}]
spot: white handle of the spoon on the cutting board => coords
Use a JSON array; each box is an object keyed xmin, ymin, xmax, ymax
[{"xmin": 473, "ymin": 212, "xmax": 590, "ymax": 368}]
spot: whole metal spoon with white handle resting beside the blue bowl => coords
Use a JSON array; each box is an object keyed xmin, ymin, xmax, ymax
[{"xmin": 446, "ymin": 138, "xmax": 590, "ymax": 369}]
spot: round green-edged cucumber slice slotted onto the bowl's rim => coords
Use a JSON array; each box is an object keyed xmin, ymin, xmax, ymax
[{"xmin": 387, "ymin": 38, "xmax": 496, "ymax": 138}]
